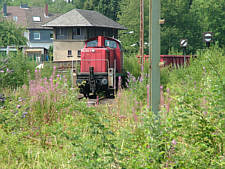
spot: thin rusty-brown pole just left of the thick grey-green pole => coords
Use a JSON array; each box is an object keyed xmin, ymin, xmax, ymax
[{"xmin": 140, "ymin": 0, "xmax": 144, "ymax": 72}]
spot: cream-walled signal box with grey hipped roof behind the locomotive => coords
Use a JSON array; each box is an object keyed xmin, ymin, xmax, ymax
[{"xmin": 43, "ymin": 9, "xmax": 126, "ymax": 62}]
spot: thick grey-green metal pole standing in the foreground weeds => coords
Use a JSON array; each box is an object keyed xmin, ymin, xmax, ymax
[{"xmin": 150, "ymin": 0, "xmax": 160, "ymax": 115}]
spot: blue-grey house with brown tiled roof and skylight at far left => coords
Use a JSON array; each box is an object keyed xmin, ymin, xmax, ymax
[{"xmin": 3, "ymin": 4, "xmax": 58, "ymax": 59}]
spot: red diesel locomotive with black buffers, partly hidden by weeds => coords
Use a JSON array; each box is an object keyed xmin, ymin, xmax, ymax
[{"xmin": 76, "ymin": 36, "xmax": 125, "ymax": 97}]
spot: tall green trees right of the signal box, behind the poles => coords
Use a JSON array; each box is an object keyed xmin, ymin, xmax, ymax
[{"xmin": 118, "ymin": 0, "xmax": 225, "ymax": 54}]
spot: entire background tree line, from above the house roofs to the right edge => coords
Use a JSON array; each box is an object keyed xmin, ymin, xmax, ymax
[{"xmin": 1, "ymin": 0, "xmax": 225, "ymax": 54}]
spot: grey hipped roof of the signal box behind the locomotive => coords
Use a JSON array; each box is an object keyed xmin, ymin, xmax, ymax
[{"xmin": 43, "ymin": 9, "xmax": 126, "ymax": 30}]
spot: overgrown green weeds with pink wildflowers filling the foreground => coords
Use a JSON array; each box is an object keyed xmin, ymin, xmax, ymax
[{"xmin": 0, "ymin": 47, "xmax": 225, "ymax": 169}]
